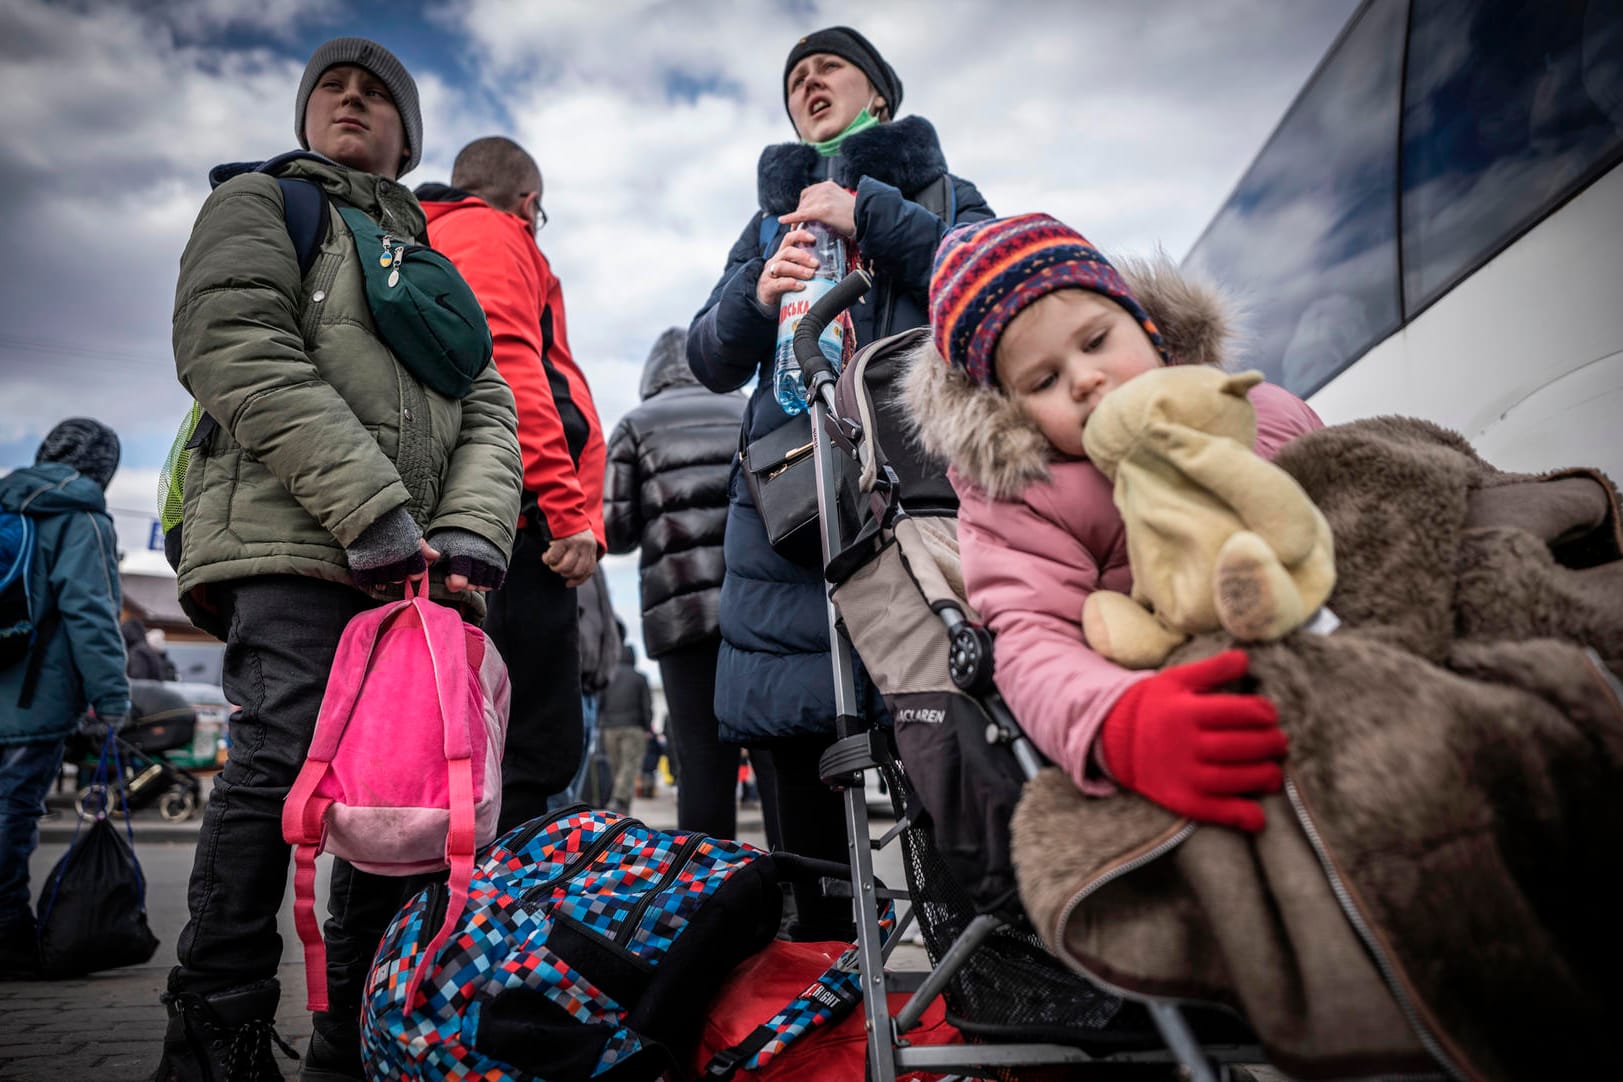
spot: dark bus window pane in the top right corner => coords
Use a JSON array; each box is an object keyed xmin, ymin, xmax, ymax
[{"xmin": 1402, "ymin": 0, "xmax": 1623, "ymax": 320}]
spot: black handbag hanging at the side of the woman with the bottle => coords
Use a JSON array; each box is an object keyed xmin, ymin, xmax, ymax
[{"xmin": 738, "ymin": 410, "xmax": 854, "ymax": 568}]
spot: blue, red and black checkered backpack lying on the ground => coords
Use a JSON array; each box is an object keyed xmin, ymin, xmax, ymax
[{"xmin": 362, "ymin": 806, "xmax": 889, "ymax": 1082}]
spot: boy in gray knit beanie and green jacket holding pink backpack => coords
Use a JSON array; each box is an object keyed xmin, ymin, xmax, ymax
[{"xmin": 154, "ymin": 25, "xmax": 523, "ymax": 1082}]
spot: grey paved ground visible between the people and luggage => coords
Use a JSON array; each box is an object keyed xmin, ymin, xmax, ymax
[{"xmin": 0, "ymin": 775, "xmax": 925, "ymax": 1082}]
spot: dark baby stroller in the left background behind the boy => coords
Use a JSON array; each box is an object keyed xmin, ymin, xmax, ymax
[{"xmin": 68, "ymin": 680, "xmax": 203, "ymax": 822}]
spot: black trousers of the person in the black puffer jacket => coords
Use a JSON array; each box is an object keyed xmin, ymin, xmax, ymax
[{"xmin": 659, "ymin": 636, "xmax": 738, "ymax": 837}]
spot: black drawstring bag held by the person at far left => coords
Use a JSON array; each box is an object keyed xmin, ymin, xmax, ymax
[{"xmin": 39, "ymin": 730, "xmax": 157, "ymax": 980}]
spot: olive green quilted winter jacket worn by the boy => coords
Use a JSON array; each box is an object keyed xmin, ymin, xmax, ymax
[{"xmin": 174, "ymin": 157, "xmax": 521, "ymax": 636}]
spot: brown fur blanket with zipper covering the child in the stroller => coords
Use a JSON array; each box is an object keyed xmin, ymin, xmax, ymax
[{"xmin": 1013, "ymin": 419, "xmax": 1623, "ymax": 1079}]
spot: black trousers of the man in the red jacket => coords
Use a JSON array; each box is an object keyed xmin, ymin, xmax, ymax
[{"xmin": 485, "ymin": 530, "xmax": 584, "ymax": 834}]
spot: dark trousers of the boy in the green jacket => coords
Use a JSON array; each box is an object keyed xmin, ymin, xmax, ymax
[{"xmin": 170, "ymin": 574, "xmax": 420, "ymax": 1019}]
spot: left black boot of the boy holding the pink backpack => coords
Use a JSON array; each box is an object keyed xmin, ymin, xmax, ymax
[{"xmin": 153, "ymin": 978, "xmax": 299, "ymax": 1082}]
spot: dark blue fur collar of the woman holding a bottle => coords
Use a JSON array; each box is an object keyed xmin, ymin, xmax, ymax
[{"xmin": 756, "ymin": 117, "xmax": 946, "ymax": 216}]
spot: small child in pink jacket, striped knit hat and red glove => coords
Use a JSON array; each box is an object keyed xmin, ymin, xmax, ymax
[{"xmin": 911, "ymin": 214, "xmax": 1319, "ymax": 831}]
